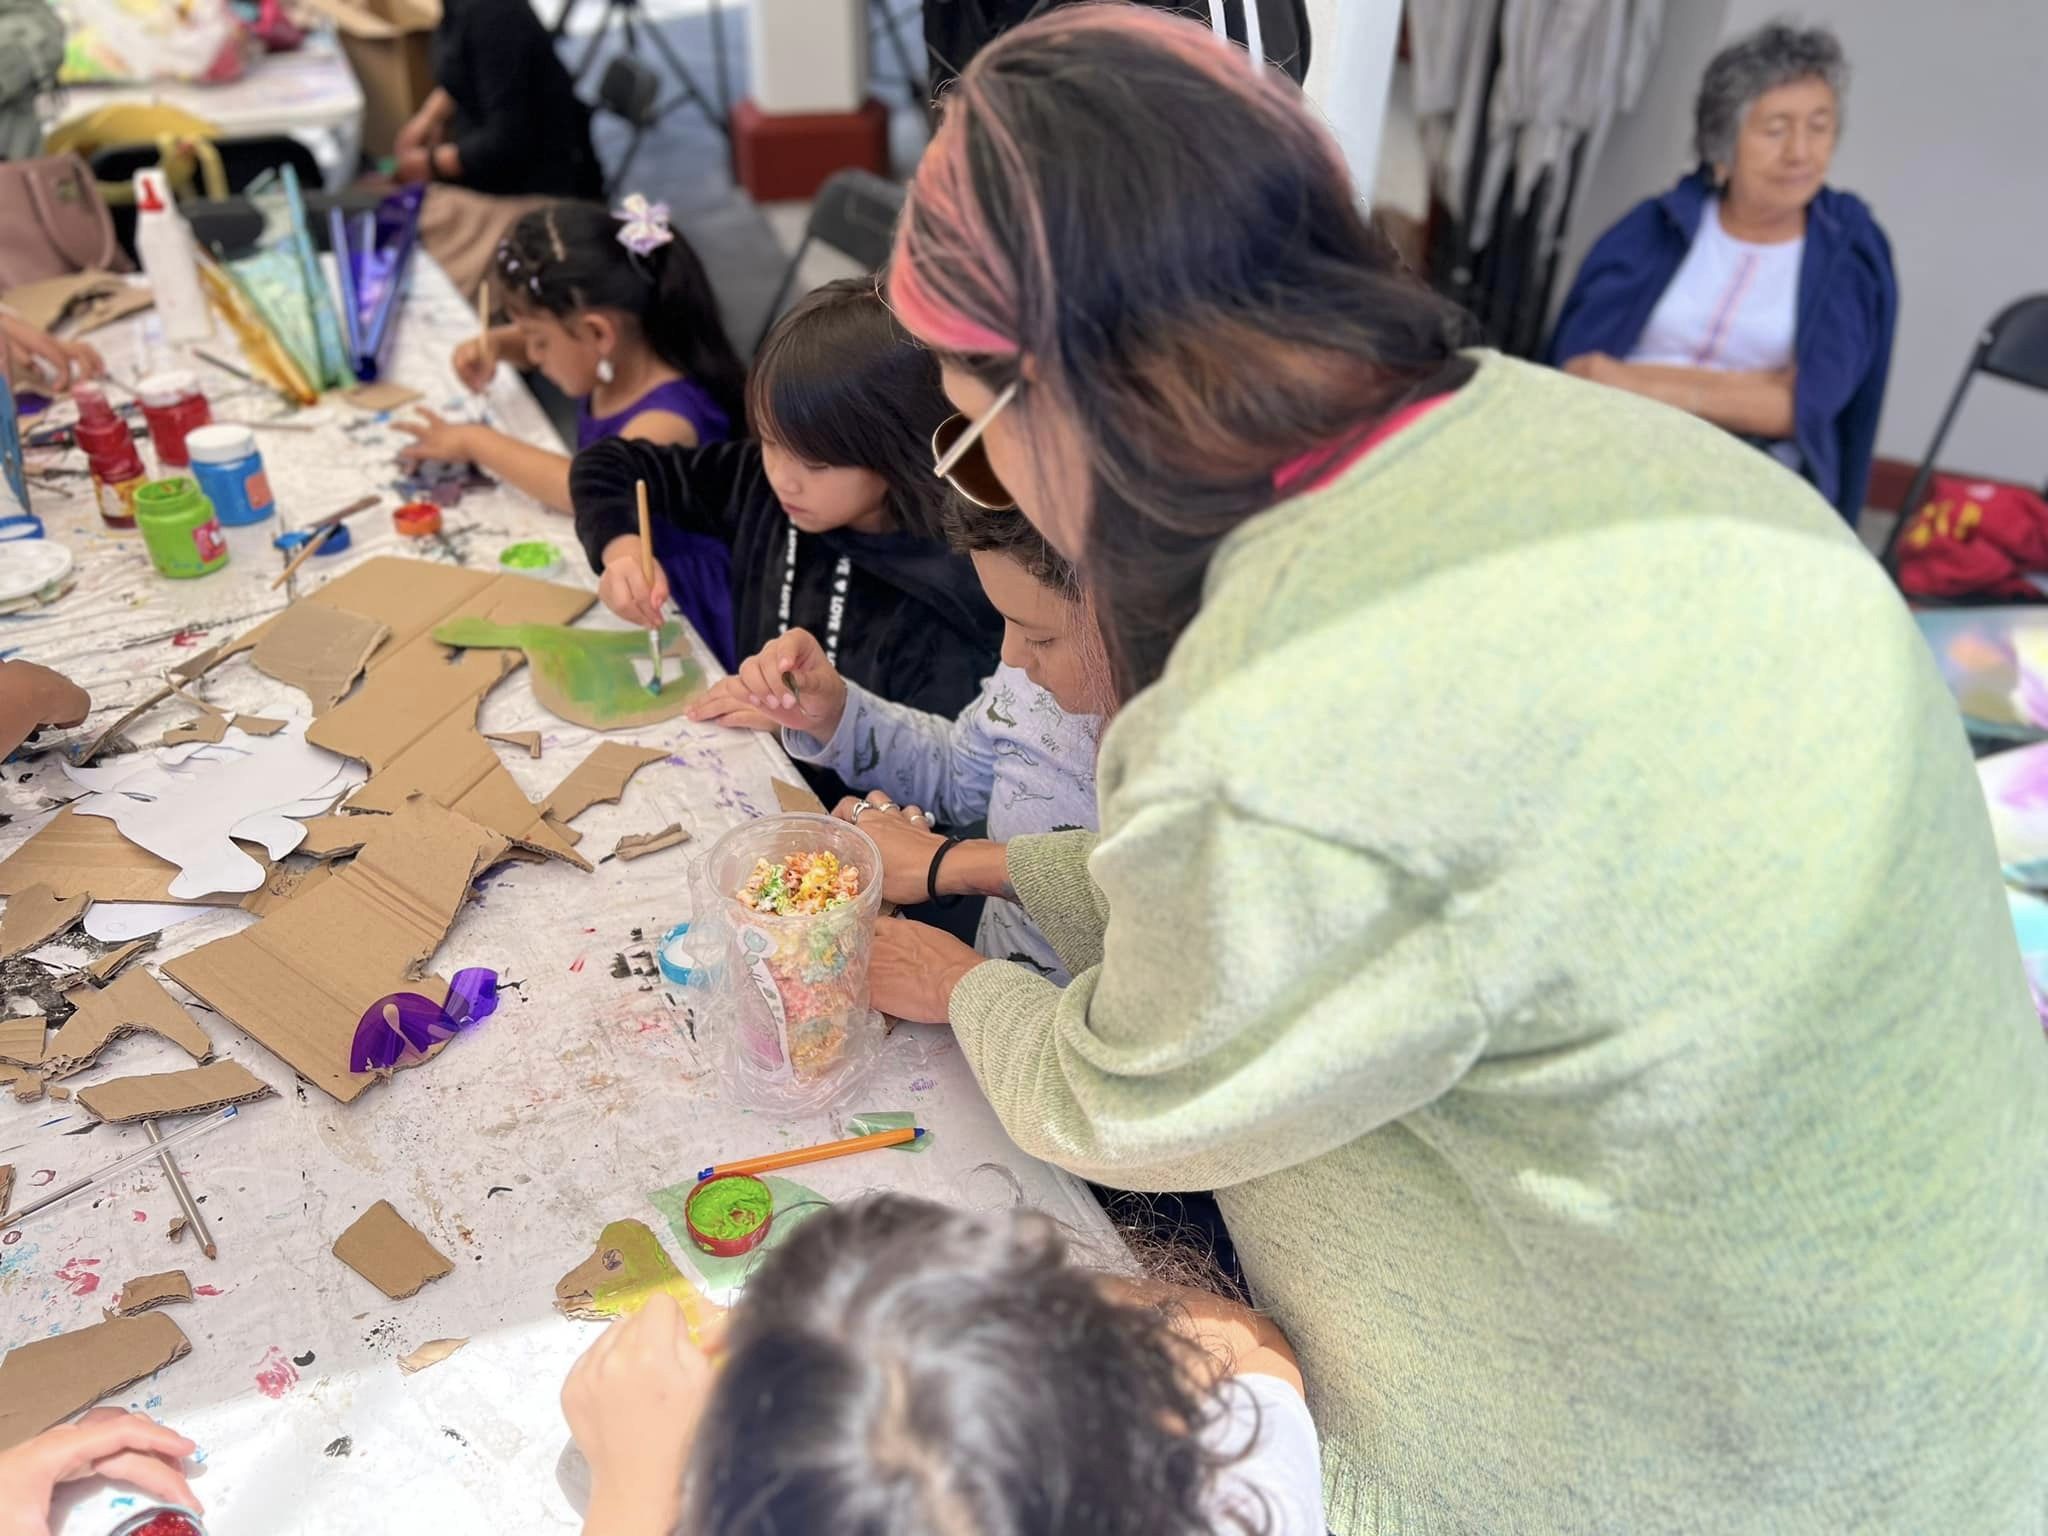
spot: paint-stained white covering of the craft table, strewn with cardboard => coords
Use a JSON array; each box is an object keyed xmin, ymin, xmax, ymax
[{"xmin": 0, "ymin": 260, "xmax": 1114, "ymax": 1536}]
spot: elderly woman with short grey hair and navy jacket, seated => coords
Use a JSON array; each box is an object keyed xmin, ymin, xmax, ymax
[{"xmin": 1550, "ymin": 25, "xmax": 1898, "ymax": 524}]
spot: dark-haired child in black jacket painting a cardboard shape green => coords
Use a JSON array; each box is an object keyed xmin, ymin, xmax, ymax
[{"xmin": 569, "ymin": 279, "xmax": 1004, "ymax": 798}]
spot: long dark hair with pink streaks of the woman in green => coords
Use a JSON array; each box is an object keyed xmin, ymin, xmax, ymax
[{"xmin": 889, "ymin": 4, "xmax": 1470, "ymax": 698}]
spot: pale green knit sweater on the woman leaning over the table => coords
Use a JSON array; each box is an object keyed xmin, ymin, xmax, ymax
[{"xmin": 952, "ymin": 354, "xmax": 2048, "ymax": 1536}]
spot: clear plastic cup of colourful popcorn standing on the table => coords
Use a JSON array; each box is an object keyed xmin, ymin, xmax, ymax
[{"xmin": 690, "ymin": 815, "xmax": 883, "ymax": 1114}]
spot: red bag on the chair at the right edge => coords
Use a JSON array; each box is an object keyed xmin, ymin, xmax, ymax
[{"xmin": 1898, "ymin": 475, "xmax": 2048, "ymax": 602}]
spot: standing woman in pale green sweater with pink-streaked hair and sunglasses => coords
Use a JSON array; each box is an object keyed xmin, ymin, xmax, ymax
[{"xmin": 874, "ymin": 6, "xmax": 2048, "ymax": 1536}]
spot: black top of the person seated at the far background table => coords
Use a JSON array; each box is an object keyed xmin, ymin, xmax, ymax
[{"xmin": 434, "ymin": 0, "xmax": 604, "ymax": 199}]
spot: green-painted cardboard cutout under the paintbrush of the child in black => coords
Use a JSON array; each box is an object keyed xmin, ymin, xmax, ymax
[{"xmin": 434, "ymin": 616, "xmax": 705, "ymax": 731}]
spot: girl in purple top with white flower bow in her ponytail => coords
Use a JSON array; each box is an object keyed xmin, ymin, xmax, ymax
[{"xmin": 399, "ymin": 195, "xmax": 745, "ymax": 518}]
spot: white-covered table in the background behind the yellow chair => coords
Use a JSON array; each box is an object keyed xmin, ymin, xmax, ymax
[{"xmin": 41, "ymin": 27, "xmax": 362, "ymax": 190}]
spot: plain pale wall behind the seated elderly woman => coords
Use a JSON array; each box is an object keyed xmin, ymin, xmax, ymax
[{"xmin": 1561, "ymin": 0, "xmax": 2048, "ymax": 485}]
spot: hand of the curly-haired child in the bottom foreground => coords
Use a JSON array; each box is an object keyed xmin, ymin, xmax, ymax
[{"xmin": 561, "ymin": 1290, "xmax": 711, "ymax": 1536}]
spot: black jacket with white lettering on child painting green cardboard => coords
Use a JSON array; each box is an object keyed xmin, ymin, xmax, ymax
[{"xmin": 569, "ymin": 438, "xmax": 1004, "ymax": 795}]
